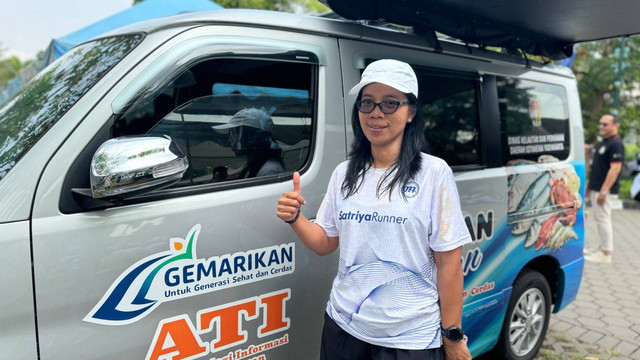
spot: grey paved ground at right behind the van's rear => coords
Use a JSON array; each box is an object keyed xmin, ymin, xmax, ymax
[{"xmin": 535, "ymin": 206, "xmax": 640, "ymax": 360}]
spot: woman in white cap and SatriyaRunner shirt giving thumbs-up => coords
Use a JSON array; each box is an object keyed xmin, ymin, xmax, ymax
[{"xmin": 278, "ymin": 60, "xmax": 471, "ymax": 360}]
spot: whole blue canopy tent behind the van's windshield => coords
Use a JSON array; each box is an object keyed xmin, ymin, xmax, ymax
[{"xmin": 0, "ymin": 0, "xmax": 223, "ymax": 105}]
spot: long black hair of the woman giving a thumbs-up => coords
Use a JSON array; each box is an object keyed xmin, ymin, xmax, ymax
[{"xmin": 342, "ymin": 90, "xmax": 426, "ymax": 200}]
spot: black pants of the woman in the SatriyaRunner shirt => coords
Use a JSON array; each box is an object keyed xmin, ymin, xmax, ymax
[{"xmin": 320, "ymin": 313, "xmax": 444, "ymax": 360}]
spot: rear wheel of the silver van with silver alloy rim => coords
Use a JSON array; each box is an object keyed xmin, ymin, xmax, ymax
[{"xmin": 497, "ymin": 269, "xmax": 551, "ymax": 360}]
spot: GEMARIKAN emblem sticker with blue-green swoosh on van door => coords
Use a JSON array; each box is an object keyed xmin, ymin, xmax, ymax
[{"xmin": 84, "ymin": 224, "xmax": 295, "ymax": 325}]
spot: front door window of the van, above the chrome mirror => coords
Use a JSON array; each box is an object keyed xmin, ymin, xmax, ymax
[{"xmin": 114, "ymin": 58, "xmax": 314, "ymax": 187}]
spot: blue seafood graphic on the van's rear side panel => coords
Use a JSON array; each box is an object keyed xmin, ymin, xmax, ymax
[{"xmin": 462, "ymin": 160, "xmax": 585, "ymax": 351}]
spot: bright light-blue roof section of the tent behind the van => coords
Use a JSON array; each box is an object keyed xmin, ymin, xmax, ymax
[{"xmin": 54, "ymin": 0, "xmax": 223, "ymax": 57}]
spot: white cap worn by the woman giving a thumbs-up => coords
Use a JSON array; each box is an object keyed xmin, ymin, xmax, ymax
[{"xmin": 349, "ymin": 59, "xmax": 418, "ymax": 98}]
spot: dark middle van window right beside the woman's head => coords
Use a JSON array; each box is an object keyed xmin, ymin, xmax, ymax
[{"xmin": 417, "ymin": 71, "xmax": 481, "ymax": 166}]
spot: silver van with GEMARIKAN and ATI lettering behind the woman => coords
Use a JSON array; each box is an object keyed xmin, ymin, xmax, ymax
[{"xmin": 0, "ymin": 10, "xmax": 596, "ymax": 360}]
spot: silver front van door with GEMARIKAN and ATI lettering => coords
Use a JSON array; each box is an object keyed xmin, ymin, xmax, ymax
[{"xmin": 33, "ymin": 26, "xmax": 346, "ymax": 359}]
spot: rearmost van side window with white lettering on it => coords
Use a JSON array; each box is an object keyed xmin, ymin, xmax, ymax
[{"xmin": 496, "ymin": 77, "xmax": 570, "ymax": 164}]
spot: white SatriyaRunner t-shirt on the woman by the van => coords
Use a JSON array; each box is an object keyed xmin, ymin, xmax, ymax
[{"xmin": 316, "ymin": 154, "xmax": 471, "ymax": 350}]
